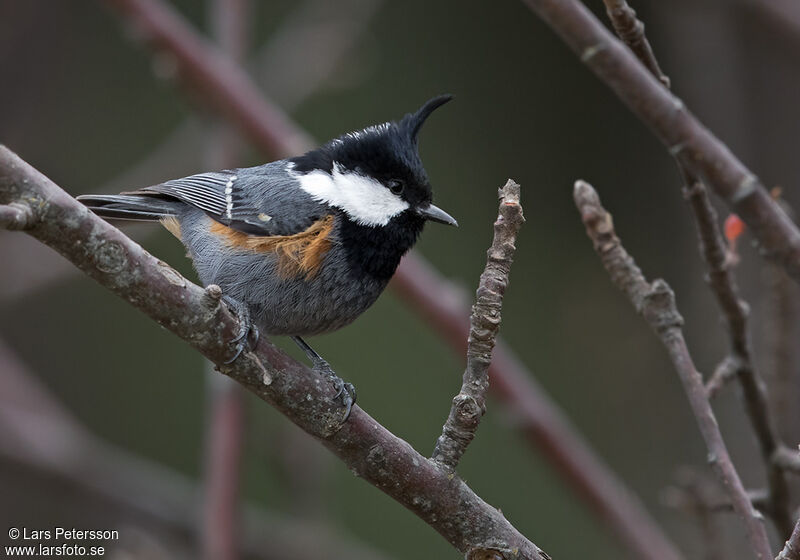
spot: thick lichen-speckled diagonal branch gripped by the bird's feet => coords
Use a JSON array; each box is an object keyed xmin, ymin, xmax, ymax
[{"xmin": 0, "ymin": 147, "xmax": 549, "ymax": 560}]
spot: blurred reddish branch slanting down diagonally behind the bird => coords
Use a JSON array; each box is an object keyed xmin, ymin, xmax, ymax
[{"xmin": 97, "ymin": 2, "xmax": 682, "ymax": 560}]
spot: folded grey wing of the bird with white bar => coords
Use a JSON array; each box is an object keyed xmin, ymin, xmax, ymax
[{"xmin": 129, "ymin": 162, "xmax": 330, "ymax": 235}]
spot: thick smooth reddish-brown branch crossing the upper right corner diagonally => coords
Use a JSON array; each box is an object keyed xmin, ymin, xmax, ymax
[{"xmin": 524, "ymin": 0, "xmax": 800, "ymax": 282}]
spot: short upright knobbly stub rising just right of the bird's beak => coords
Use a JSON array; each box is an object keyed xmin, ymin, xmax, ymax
[{"xmin": 431, "ymin": 179, "xmax": 525, "ymax": 471}]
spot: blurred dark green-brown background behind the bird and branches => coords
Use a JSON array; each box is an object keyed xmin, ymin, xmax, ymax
[{"xmin": 0, "ymin": 0, "xmax": 800, "ymax": 560}]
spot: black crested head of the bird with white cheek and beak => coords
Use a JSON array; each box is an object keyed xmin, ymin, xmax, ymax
[{"xmin": 290, "ymin": 95, "xmax": 458, "ymax": 226}]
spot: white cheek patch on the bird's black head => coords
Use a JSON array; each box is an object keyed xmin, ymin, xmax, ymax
[{"xmin": 289, "ymin": 163, "xmax": 409, "ymax": 226}]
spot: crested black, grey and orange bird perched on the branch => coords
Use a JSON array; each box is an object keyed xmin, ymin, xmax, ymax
[{"xmin": 77, "ymin": 95, "xmax": 458, "ymax": 421}]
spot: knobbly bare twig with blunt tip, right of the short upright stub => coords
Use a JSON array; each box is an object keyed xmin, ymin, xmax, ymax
[{"xmin": 574, "ymin": 181, "xmax": 772, "ymax": 560}]
